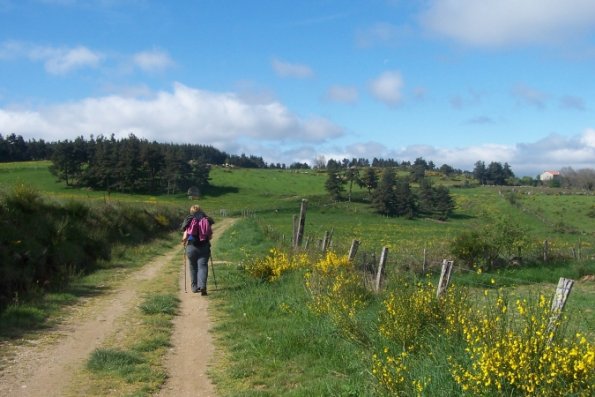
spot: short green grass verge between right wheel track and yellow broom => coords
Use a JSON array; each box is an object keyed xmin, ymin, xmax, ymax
[{"xmin": 211, "ymin": 266, "xmax": 374, "ymax": 396}]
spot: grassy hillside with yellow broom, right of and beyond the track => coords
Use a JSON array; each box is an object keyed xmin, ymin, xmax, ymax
[{"xmin": 0, "ymin": 163, "xmax": 595, "ymax": 396}]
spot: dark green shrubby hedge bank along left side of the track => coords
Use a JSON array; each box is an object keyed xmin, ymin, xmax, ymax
[{"xmin": 0, "ymin": 185, "xmax": 180, "ymax": 309}]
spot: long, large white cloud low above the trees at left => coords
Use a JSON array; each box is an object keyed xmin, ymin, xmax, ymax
[{"xmin": 0, "ymin": 83, "xmax": 342, "ymax": 149}]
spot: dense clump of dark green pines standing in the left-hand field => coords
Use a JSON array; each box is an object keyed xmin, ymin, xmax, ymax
[{"xmin": 50, "ymin": 134, "xmax": 228, "ymax": 194}]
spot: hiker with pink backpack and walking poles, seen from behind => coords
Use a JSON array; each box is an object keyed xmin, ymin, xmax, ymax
[{"xmin": 181, "ymin": 204, "xmax": 214, "ymax": 296}]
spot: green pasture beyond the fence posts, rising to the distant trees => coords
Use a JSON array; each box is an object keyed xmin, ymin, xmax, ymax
[{"xmin": 0, "ymin": 161, "xmax": 595, "ymax": 262}]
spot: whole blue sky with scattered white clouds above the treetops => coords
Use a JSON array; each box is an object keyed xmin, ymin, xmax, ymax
[{"xmin": 0, "ymin": 0, "xmax": 595, "ymax": 176}]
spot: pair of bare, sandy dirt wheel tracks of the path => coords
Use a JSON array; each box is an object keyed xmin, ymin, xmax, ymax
[{"xmin": 0, "ymin": 219, "xmax": 233, "ymax": 397}]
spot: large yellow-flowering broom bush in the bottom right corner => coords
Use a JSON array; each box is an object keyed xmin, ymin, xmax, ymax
[{"xmin": 450, "ymin": 294, "xmax": 595, "ymax": 396}]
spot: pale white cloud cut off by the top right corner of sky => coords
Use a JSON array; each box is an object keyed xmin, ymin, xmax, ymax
[{"xmin": 420, "ymin": 0, "xmax": 595, "ymax": 46}]
